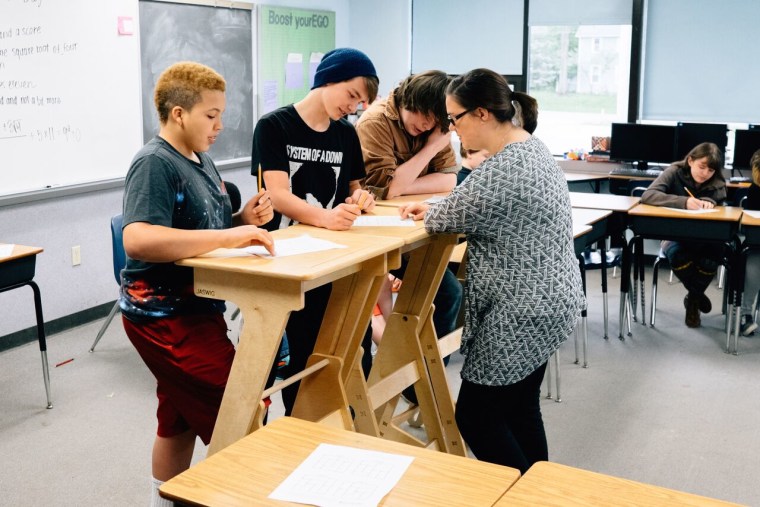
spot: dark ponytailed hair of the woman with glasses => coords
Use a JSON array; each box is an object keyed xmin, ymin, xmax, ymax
[{"xmin": 446, "ymin": 69, "xmax": 538, "ymax": 134}]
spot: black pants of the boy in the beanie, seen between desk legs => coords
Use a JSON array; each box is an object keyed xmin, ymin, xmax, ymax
[{"xmin": 266, "ymin": 284, "xmax": 372, "ymax": 415}]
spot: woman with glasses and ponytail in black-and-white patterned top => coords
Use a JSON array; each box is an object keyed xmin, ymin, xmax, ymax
[{"xmin": 401, "ymin": 69, "xmax": 584, "ymax": 473}]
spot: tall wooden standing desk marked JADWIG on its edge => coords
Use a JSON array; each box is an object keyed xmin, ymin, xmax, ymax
[{"xmin": 177, "ymin": 227, "xmax": 403, "ymax": 454}]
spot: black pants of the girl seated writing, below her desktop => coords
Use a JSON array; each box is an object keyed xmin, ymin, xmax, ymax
[{"xmin": 662, "ymin": 241, "xmax": 725, "ymax": 294}]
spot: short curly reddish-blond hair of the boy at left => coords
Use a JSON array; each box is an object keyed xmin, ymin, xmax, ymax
[{"xmin": 153, "ymin": 62, "xmax": 227, "ymax": 125}]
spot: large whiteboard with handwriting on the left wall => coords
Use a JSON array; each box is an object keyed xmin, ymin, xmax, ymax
[{"xmin": 0, "ymin": 0, "xmax": 142, "ymax": 196}]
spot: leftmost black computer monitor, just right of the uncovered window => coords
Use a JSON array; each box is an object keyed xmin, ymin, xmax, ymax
[{"xmin": 610, "ymin": 123, "xmax": 676, "ymax": 171}]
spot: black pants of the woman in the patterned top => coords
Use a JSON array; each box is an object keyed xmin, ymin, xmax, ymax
[{"xmin": 456, "ymin": 363, "xmax": 549, "ymax": 474}]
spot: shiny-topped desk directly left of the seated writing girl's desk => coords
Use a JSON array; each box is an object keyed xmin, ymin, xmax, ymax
[{"xmin": 570, "ymin": 192, "xmax": 641, "ymax": 340}]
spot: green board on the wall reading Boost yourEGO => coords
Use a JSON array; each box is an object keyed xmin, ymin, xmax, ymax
[{"xmin": 258, "ymin": 5, "xmax": 335, "ymax": 114}]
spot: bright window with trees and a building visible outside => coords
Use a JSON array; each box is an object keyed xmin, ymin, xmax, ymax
[{"xmin": 528, "ymin": 0, "xmax": 632, "ymax": 155}]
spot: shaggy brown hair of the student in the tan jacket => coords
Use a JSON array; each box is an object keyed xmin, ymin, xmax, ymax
[{"xmin": 393, "ymin": 70, "xmax": 449, "ymax": 132}]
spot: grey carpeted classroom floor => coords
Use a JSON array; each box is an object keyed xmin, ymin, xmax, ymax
[{"xmin": 0, "ymin": 271, "xmax": 760, "ymax": 506}]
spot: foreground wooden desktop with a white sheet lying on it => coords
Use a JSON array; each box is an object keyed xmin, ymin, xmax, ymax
[{"xmin": 160, "ymin": 417, "xmax": 520, "ymax": 507}]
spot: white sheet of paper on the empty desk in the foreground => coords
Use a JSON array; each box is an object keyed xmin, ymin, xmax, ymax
[{"xmin": 268, "ymin": 444, "xmax": 414, "ymax": 507}]
